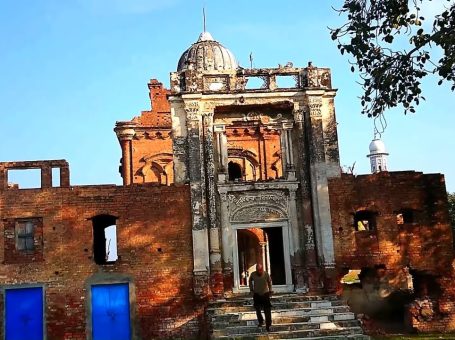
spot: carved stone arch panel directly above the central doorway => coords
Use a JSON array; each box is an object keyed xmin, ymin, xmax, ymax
[{"xmin": 228, "ymin": 190, "xmax": 289, "ymax": 223}]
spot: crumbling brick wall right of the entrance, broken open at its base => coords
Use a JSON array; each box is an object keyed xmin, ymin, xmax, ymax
[{"xmin": 329, "ymin": 171, "xmax": 455, "ymax": 331}]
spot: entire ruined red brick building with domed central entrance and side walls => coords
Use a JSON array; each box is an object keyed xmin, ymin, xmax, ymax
[{"xmin": 0, "ymin": 32, "xmax": 455, "ymax": 340}]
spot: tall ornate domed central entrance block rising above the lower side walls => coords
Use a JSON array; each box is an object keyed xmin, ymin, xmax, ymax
[{"xmin": 115, "ymin": 32, "xmax": 350, "ymax": 295}]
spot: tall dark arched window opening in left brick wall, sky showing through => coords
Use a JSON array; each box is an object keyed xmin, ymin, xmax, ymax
[{"xmin": 92, "ymin": 215, "xmax": 118, "ymax": 264}]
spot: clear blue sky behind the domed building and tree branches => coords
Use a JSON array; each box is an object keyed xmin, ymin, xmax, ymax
[{"xmin": 0, "ymin": 0, "xmax": 455, "ymax": 192}]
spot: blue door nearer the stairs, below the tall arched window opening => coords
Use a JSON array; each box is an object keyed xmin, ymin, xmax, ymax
[{"xmin": 92, "ymin": 283, "xmax": 131, "ymax": 340}]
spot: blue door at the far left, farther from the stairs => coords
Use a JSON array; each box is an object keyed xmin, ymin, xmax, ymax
[{"xmin": 5, "ymin": 287, "xmax": 44, "ymax": 340}]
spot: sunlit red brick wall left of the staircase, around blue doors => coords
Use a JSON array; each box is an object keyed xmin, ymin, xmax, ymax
[{"xmin": 0, "ymin": 184, "xmax": 204, "ymax": 340}]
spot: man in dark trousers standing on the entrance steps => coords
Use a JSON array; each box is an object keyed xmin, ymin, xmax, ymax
[{"xmin": 248, "ymin": 263, "xmax": 272, "ymax": 332}]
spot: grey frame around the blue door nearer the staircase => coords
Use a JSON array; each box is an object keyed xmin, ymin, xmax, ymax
[{"xmin": 85, "ymin": 273, "xmax": 139, "ymax": 340}]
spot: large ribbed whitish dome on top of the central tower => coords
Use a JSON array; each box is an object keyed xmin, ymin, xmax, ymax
[{"xmin": 177, "ymin": 32, "xmax": 238, "ymax": 72}]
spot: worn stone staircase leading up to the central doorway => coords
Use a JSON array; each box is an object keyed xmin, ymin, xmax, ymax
[{"xmin": 207, "ymin": 294, "xmax": 370, "ymax": 340}]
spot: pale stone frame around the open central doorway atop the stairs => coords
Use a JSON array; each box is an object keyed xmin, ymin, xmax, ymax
[{"xmin": 231, "ymin": 221, "xmax": 294, "ymax": 293}]
